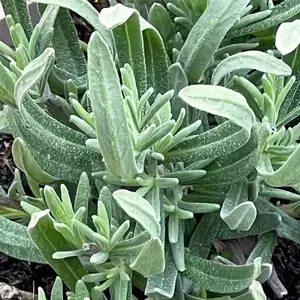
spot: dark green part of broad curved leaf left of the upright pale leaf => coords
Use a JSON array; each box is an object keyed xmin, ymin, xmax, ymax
[{"xmin": 8, "ymin": 97, "xmax": 104, "ymax": 182}]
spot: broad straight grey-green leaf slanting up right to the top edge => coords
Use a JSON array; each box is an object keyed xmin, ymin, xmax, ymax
[{"xmin": 177, "ymin": 0, "xmax": 250, "ymax": 83}]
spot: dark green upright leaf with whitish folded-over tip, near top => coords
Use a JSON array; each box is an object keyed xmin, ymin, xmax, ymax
[{"xmin": 99, "ymin": 3, "xmax": 147, "ymax": 97}]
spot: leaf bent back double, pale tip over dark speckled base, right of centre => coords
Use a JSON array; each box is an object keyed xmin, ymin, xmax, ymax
[{"xmin": 164, "ymin": 85, "xmax": 255, "ymax": 161}]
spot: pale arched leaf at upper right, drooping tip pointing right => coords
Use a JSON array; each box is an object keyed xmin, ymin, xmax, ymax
[{"xmin": 212, "ymin": 51, "xmax": 292, "ymax": 85}]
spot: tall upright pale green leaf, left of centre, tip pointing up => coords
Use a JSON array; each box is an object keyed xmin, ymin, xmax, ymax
[{"xmin": 88, "ymin": 32, "xmax": 138, "ymax": 178}]
